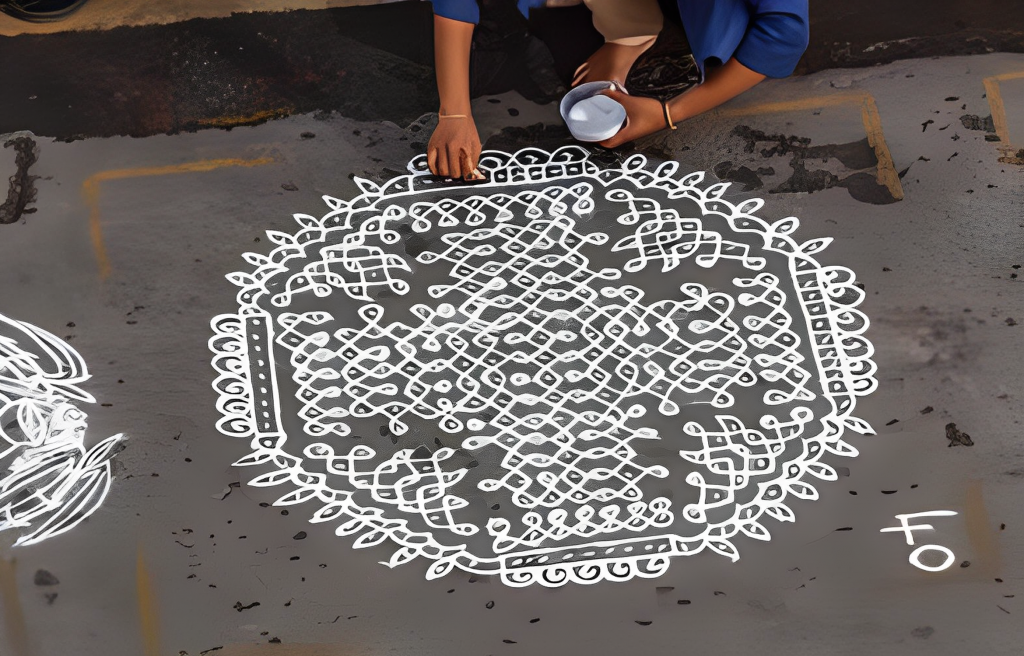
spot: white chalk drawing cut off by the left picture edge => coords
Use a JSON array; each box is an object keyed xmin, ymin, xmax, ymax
[{"xmin": 0, "ymin": 315, "xmax": 123, "ymax": 544}]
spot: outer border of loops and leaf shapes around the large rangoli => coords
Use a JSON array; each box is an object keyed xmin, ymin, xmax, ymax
[{"xmin": 209, "ymin": 145, "xmax": 878, "ymax": 586}]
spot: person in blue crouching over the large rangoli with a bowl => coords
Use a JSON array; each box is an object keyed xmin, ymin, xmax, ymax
[{"xmin": 427, "ymin": 0, "xmax": 808, "ymax": 177}]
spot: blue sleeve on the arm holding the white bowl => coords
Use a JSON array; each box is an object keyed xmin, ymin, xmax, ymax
[{"xmin": 733, "ymin": 0, "xmax": 810, "ymax": 78}]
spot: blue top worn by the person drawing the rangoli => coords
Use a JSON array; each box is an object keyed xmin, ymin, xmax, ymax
[{"xmin": 433, "ymin": 0, "xmax": 809, "ymax": 78}]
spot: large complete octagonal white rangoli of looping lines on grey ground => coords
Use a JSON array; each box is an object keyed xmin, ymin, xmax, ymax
[{"xmin": 210, "ymin": 146, "xmax": 877, "ymax": 585}]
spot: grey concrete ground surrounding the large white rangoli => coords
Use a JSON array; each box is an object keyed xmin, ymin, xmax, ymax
[{"xmin": 0, "ymin": 6, "xmax": 1024, "ymax": 656}]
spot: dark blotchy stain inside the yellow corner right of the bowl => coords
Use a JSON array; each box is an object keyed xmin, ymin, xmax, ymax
[{"xmin": 714, "ymin": 125, "xmax": 896, "ymax": 205}]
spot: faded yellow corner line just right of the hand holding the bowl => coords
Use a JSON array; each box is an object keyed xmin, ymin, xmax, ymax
[{"xmin": 718, "ymin": 92, "xmax": 901, "ymax": 201}]
